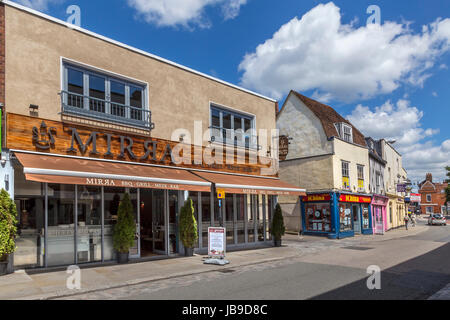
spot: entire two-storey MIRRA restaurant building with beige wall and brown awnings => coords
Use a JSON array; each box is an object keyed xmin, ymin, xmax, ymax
[{"xmin": 0, "ymin": 1, "xmax": 304, "ymax": 268}]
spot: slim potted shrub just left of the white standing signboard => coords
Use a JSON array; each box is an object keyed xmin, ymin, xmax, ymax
[{"xmin": 180, "ymin": 198, "xmax": 198, "ymax": 257}]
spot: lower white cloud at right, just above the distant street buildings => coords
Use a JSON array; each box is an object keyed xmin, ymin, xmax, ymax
[{"xmin": 348, "ymin": 100, "xmax": 450, "ymax": 182}]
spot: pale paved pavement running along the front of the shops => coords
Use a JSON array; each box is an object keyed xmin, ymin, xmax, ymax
[{"xmin": 0, "ymin": 222, "xmax": 427, "ymax": 299}]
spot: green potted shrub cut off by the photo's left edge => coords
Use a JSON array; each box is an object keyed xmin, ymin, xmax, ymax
[{"xmin": 0, "ymin": 189, "xmax": 17, "ymax": 275}]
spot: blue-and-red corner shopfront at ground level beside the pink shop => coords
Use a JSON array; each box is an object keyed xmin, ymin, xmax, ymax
[{"xmin": 302, "ymin": 192, "xmax": 373, "ymax": 239}]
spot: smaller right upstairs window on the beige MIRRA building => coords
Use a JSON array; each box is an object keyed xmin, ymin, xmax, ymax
[{"xmin": 210, "ymin": 105, "xmax": 257, "ymax": 149}]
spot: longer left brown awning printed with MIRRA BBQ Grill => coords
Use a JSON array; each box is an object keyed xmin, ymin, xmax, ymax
[{"xmin": 15, "ymin": 152, "xmax": 211, "ymax": 192}]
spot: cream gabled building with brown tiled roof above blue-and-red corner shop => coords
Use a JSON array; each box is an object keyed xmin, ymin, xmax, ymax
[{"xmin": 277, "ymin": 91, "xmax": 373, "ymax": 238}]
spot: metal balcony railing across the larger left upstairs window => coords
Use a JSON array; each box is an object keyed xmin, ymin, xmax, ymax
[{"xmin": 60, "ymin": 91, "xmax": 154, "ymax": 130}]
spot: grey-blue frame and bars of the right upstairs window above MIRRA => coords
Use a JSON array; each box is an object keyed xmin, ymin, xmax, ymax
[{"xmin": 209, "ymin": 102, "xmax": 258, "ymax": 149}]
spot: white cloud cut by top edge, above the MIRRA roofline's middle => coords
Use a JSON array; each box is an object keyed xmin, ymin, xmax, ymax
[{"xmin": 128, "ymin": 0, "xmax": 247, "ymax": 28}]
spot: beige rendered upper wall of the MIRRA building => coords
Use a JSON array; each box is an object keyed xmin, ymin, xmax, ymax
[{"xmin": 5, "ymin": 5, "xmax": 276, "ymax": 145}]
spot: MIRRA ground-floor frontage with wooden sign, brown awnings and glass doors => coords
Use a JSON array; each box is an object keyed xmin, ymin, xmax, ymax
[{"xmin": 8, "ymin": 114, "xmax": 305, "ymax": 268}]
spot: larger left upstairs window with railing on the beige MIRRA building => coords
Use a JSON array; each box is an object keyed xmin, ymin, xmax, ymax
[{"xmin": 62, "ymin": 64, "xmax": 150, "ymax": 126}]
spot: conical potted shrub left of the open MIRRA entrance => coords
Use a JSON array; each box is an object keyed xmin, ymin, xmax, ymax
[{"xmin": 113, "ymin": 193, "xmax": 136, "ymax": 263}]
